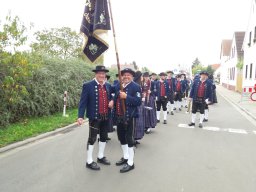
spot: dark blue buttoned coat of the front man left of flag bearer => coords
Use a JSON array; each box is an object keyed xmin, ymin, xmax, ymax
[{"xmin": 78, "ymin": 80, "xmax": 112, "ymax": 120}]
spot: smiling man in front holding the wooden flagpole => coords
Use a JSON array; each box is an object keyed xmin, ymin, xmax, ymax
[{"xmin": 113, "ymin": 68, "xmax": 142, "ymax": 173}]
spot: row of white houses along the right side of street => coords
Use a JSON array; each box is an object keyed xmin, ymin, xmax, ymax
[{"xmin": 216, "ymin": 0, "xmax": 256, "ymax": 92}]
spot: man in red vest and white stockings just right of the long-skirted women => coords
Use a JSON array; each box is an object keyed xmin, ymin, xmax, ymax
[{"xmin": 155, "ymin": 72, "xmax": 170, "ymax": 124}]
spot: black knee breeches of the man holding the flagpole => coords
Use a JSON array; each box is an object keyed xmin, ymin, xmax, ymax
[{"xmin": 117, "ymin": 118, "xmax": 134, "ymax": 147}]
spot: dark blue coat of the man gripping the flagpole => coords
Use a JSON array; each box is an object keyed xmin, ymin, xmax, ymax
[{"xmin": 113, "ymin": 81, "xmax": 141, "ymax": 120}]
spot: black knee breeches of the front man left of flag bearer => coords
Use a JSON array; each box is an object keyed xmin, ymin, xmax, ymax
[{"xmin": 88, "ymin": 120, "xmax": 109, "ymax": 145}]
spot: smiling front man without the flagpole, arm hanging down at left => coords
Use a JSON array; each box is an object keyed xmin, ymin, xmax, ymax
[{"xmin": 77, "ymin": 65, "xmax": 113, "ymax": 170}]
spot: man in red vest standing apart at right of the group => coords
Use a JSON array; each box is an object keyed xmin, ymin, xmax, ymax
[{"xmin": 189, "ymin": 71, "xmax": 212, "ymax": 128}]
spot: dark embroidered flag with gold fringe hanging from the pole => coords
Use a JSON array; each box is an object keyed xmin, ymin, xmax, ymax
[{"xmin": 80, "ymin": 0, "xmax": 111, "ymax": 62}]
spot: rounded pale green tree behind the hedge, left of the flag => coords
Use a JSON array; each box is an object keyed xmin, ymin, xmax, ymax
[{"xmin": 31, "ymin": 27, "xmax": 83, "ymax": 59}]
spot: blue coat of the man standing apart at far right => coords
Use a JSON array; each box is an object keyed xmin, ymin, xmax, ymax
[{"xmin": 189, "ymin": 79, "xmax": 212, "ymax": 102}]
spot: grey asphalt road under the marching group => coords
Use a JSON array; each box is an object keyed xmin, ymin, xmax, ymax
[{"xmin": 0, "ymin": 93, "xmax": 256, "ymax": 192}]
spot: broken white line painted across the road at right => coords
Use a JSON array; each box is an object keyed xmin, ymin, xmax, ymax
[{"xmin": 178, "ymin": 124, "xmax": 249, "ymax": 135}]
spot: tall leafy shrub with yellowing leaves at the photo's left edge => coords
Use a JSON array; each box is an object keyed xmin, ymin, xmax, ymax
[{"xmin": 0, "ymin": 15, "xmax": 33, "ymax": 125}]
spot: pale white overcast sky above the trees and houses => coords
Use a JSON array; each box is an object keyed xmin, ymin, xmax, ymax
[{"xmin": 0, "ymin": 0, "xmax": 252, "ymax": 72}]
